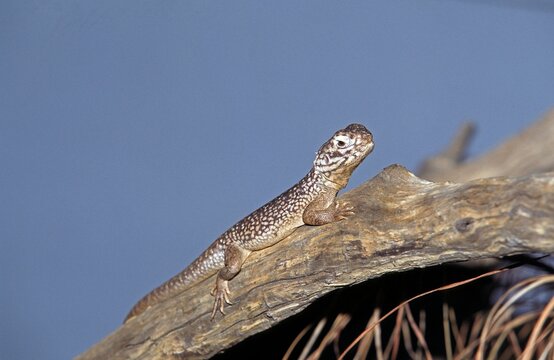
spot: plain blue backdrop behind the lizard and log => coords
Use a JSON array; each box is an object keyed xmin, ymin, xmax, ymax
[{"xmin": 0, "ymin": 0, "xmax": 554, "ymax": 359}]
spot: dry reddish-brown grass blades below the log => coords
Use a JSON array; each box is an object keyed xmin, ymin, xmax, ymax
[{"xmin": 284, "ymin": 268, "xmax": 554, "ymax": 360}]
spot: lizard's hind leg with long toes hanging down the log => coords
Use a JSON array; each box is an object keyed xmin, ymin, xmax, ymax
[{"xmin": 211, "ymin": 243, "xmax": 251, "ymax": 320}]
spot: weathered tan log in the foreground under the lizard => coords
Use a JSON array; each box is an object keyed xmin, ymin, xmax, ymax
[{"xmin": 78, "ymin": 165, "xmax": 554, "ymax": 360}]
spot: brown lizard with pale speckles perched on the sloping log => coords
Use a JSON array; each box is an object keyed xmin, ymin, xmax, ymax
[{"xmin": 124, "ymin": 124, "xmax": 374, "ymax": 322}]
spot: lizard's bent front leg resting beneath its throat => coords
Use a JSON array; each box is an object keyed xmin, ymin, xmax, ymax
[{"xmin": 302, "ymin": 192, "xmax": 354, "ymax": 225}]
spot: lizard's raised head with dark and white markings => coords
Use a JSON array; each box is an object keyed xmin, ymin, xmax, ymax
[{"xmin": 314, "ymin": 124, "xmax": 374, "ymax": 190}]
